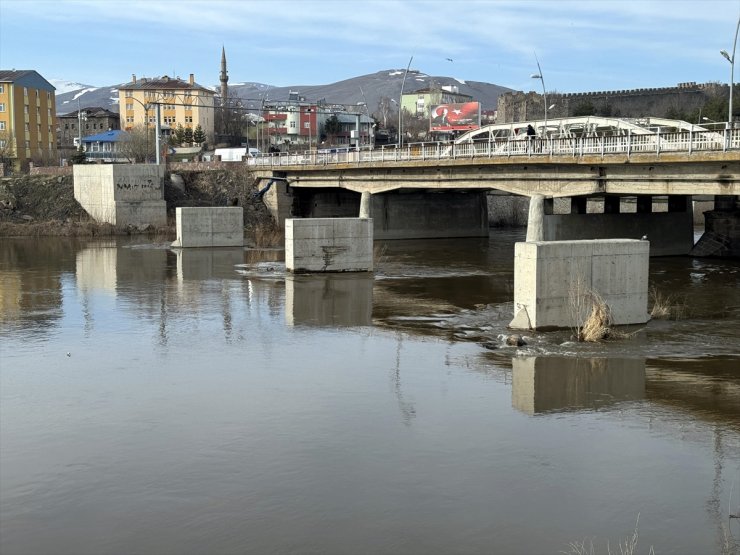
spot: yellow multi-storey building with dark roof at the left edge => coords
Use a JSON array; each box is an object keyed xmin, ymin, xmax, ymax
[{"xmin": 0, "ymin": 70, "xmax": 58, "ymax": 171}]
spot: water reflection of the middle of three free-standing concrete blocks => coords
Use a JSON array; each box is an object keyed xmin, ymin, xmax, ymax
[{"xmin": 285, "ymin": 272, "xmax": 374, "ymax": 326}]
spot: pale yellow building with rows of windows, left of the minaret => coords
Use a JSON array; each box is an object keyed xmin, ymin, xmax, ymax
[{"xmin": 118, "ymin": 73, "xmax": 216, "ymax": 141}]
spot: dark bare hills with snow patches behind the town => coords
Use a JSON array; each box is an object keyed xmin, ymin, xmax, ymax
[{"xmin": 56, "ymin": 69, "xmax": 511, "ymax": 114}]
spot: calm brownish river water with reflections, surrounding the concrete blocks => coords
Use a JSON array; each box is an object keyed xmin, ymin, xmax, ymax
[{"xmin": 0, "ymin": 230, "xmax": 740, "ymax": 555}]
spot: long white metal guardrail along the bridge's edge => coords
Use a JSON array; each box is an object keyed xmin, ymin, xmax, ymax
[{"xmin": 246, "ymin": 128, "xmax": 740, "ymax": 168}]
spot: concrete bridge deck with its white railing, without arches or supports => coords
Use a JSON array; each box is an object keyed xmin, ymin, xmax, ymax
[{"xmin": 249, "ymin": 129, "xmax": 740, "ymax": 197}]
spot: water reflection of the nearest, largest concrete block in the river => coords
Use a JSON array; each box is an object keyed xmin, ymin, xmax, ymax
[{"xmin": 511, "ymin": 357, "xmax": 645, "ymax": 414}]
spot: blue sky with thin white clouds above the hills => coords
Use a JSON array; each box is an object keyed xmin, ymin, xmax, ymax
[{"xmin": 0, "ymin": 0, "xmax": 740, "ymax": 93}]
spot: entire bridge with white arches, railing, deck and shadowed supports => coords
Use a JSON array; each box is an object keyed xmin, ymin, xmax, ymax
[{"xmin": 247, "ymin": 117, "xmax": 740, "ymax": 254}]
